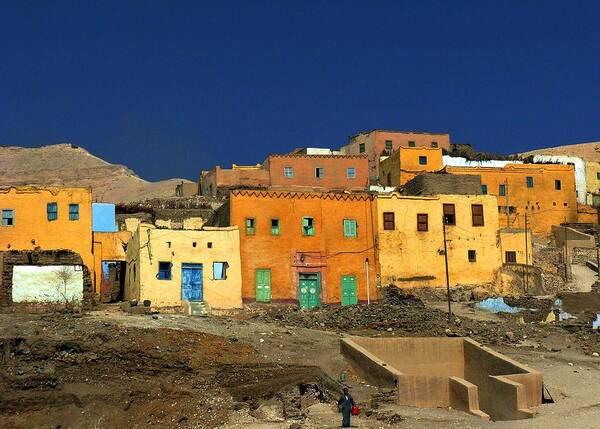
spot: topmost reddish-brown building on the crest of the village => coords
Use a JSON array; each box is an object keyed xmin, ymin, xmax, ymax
[{"xmin": 340, "ymin": 130, "xmax": 450, "ymax": 184}]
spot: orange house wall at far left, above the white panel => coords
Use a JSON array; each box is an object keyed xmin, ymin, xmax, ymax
[{"xmin": 0, "ymin": 186, "xmax": 94, "ymax": 288}]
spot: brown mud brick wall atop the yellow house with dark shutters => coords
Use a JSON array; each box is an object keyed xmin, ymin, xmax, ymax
[{"xmin": 402, "ymin": 173, "xmax": 481, "ymax": 196}]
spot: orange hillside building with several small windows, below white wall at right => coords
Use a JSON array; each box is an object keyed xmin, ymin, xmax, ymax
[{"xmin": 445, "ymin": 164, "xmax": 577, "ymax": 234}]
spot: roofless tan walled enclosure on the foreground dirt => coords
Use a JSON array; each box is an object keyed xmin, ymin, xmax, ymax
[{"xmin": 341, "ymin": 337, "xmax": 543, "ymax": 420}]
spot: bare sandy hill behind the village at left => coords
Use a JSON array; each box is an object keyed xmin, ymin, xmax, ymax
[{"xmin": 0, "ymin": 144, "xmax": 189, "ymax": 203}]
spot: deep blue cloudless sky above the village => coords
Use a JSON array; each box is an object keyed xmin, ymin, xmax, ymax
[{"xmin": 0, "ymin": 0, "xmax": 600, "ymax": 179}]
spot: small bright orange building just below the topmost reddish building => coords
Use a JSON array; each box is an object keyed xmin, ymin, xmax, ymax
[{"xmin": 379, "ymin": 147, "xmax": 444, "ymax": 186}]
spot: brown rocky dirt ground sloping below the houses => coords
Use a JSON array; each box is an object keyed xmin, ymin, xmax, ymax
[{"xmin": 0, "ymin": 294, "xmax": 600, "ymax": 429}]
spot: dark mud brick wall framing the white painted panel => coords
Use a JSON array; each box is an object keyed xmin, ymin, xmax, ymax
[{"xmin": 0, "ymin": 250, "xmax": 94, "ymax": 307}]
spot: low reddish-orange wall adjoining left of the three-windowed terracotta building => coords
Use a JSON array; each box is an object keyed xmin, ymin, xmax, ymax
[{"xmin": 200, "ymin": 164, "xmax": 269, "ymax": 196}]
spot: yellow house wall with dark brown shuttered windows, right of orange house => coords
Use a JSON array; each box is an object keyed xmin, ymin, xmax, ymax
[{"xmin": 377, "ymin": 193, "xmax": 502, "ymax": 288}]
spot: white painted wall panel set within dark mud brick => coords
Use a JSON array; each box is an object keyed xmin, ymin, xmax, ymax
[{"xmin": 12, "ymin": 265, "xmax": 83, "ymax": 302}]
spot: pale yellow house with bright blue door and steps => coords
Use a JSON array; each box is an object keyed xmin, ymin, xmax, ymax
[{"xmin": 124, "ymin": 223, "xmax": 242, "ymax": 308}]
